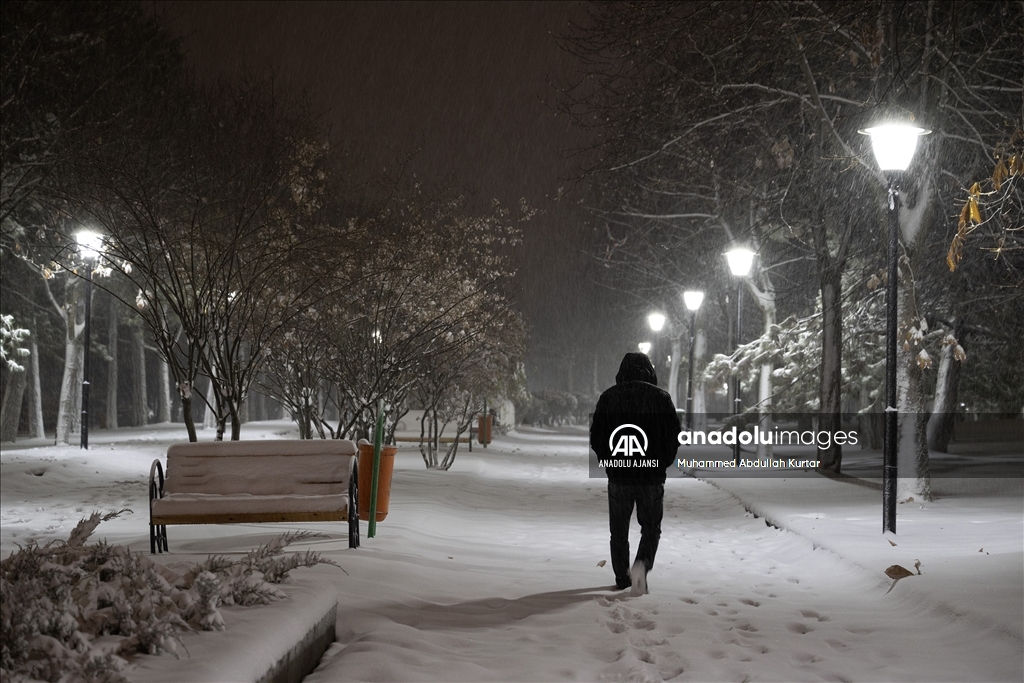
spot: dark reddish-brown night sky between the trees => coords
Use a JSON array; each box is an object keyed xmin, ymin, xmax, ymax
[{"xmin": 157, "ymin": 1, "xmax": 622, "ymax": 384}]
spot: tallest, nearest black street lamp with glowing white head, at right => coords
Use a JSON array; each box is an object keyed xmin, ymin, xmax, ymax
[{"xmin": 860, "ymin": 124, "xmax": 931, "ymax": 533}]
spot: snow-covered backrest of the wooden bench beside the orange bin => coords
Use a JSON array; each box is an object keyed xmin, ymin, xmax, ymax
[{"xmin": 164, "ymin": 439, "xmax": 356, "ymax": 496}]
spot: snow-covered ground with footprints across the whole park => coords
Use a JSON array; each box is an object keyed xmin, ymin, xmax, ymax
[{"xmin": 0, "ymin": 422, "xmax": 1024, "ymax": 683}]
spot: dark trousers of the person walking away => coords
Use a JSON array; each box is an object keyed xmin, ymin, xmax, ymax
[{"xmin": 608, "ymin": 481, "xmax": 665, "ymax": 587}]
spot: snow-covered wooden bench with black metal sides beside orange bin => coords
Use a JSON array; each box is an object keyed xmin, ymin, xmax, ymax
[{"xmin": 150, "ymin": 439, "xmax": 359, "ymax": 553}]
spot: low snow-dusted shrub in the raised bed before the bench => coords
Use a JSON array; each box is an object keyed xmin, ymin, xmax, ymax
[{"xmin": 0, "ymin": 510, "xmax": 342, "ymax": 683}]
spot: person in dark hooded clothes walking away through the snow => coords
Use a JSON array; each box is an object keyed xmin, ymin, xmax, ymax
[{"xmin": 590, "ymin": 353, "xmax": 680, "ymax": 595}]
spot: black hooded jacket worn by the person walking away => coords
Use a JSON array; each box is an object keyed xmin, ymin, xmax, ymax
[{"xmin": 590, "ymin": 353, "xmax": 681, "ymax": 483}]
